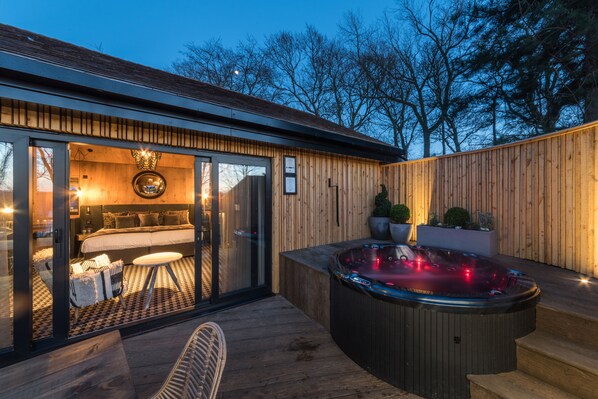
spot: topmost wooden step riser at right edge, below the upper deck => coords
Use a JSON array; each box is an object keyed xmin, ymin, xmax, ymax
[{"xmin": 536, "ymin": 304, "xmax": 598, "ymax": 349}]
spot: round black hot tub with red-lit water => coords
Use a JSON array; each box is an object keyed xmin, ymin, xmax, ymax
[{"xmin": 330, "ymin": 244, "xmax": 540, "ymax": 398}]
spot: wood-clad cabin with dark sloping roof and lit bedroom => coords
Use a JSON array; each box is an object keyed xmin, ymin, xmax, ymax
[{"xmin": 0, "ymin": 25, "xmax": 401, "ymax": 363}]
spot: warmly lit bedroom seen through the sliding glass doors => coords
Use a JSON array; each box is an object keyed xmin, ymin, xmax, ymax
[{"xmin": 25, "ymin": 143, "xmax": 268, "ymax": 341}]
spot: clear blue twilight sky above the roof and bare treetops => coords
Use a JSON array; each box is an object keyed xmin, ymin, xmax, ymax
[{"xmin": 0, "ymin": 0, "xmax": 396, "ymax": 69}]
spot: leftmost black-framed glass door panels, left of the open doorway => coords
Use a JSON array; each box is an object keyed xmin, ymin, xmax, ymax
[{"xmin": 0, "ymin": 132, "xmax": 69, "ymax": 353}]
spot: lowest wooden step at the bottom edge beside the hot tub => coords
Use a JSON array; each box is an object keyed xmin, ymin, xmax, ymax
[{"xmin": 467, "ymin": 371, "xmax": 578, "ymax": 399}]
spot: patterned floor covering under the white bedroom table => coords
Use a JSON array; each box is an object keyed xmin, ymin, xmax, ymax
[{"xmin": 33, "ymin": 250, "xmax": 216, "ymax": 339}]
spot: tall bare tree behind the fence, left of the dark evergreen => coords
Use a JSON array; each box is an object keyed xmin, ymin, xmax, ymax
[{"xmin": 361, "ymin": 0, "xmax": 474, "ymax": 157}]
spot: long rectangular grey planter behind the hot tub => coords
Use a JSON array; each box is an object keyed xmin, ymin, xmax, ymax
[{"xmin": 417, "ymin": 226, "xmax": 498, "ymax": 256}]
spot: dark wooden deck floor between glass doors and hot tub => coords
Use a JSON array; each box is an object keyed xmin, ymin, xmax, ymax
[{"xmin": 124, "ymin": 296, "xmax": 418, "ymax": 399}]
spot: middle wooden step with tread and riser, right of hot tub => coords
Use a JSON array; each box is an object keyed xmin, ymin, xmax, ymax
[{"xmin": 516, "ymin": 331, "xmax": 598, "ymax": 399}]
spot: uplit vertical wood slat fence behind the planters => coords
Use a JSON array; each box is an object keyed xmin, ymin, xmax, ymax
[{"xmin": 382, "ymin": 122, "xmax": 598, "ymax": 277}]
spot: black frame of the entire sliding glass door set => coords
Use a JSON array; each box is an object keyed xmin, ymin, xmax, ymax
[{"xmin": 0, "ymin": 126, "xmax": 272, "ymax": 367}]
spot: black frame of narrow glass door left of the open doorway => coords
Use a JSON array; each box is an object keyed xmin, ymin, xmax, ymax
[{"xmin": 5, "ymin": 134, "xmax": 70, "ymax": 355}]
